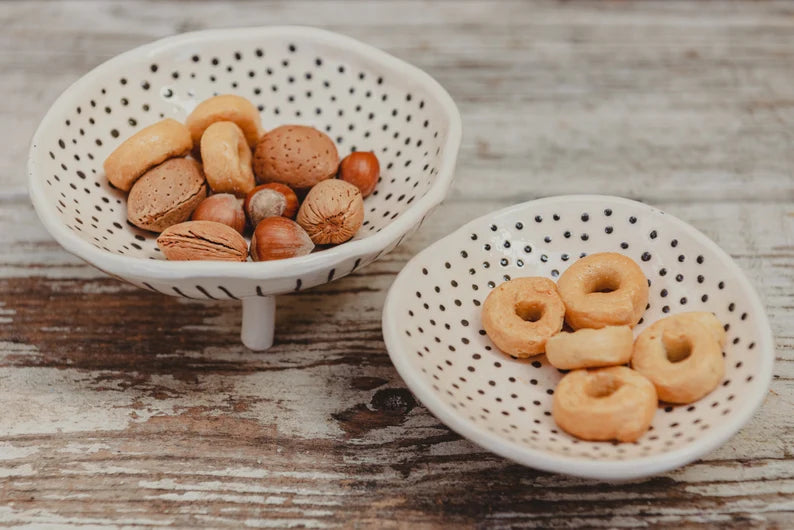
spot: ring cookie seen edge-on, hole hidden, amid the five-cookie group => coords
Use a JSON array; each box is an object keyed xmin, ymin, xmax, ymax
[{"xmin": 546, "ymin": 326, "xmax": 634, "ymax": 370}]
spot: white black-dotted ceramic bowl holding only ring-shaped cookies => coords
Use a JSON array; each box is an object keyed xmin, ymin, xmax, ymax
[{"xmin": 383, "ymin": 195, "xmax": 774, "ymax": 480}]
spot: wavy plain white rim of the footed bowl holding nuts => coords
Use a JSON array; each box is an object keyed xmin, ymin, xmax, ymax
[{"xmin": 28, "ymin": 26, "xmax": 462, "ymax": 280}]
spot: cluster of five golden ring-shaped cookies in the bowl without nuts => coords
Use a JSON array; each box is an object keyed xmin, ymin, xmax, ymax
[{"xmin": 482, "ymin": 252, "xmax": 725, "ymax": 442}]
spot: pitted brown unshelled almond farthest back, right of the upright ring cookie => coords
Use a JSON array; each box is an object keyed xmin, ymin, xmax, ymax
[{"xmin": 254, "ymin": 125, "xmax": 339, "ymax": 190}]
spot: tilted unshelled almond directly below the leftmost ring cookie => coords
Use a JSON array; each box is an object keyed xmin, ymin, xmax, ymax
[{"xmin": 127, "ymin": 158, "xmax": 207, "ymax": 232}]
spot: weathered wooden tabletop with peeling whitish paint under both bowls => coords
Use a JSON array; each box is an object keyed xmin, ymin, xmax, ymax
[{"xmin": 0, "ymin": 0, "xmax": 794, "ymax": 528}]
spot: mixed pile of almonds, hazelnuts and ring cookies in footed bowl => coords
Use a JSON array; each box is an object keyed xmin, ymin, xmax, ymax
[{"xmin": 104, "ymin": 95, "xmax": 380, "ymax": 261}]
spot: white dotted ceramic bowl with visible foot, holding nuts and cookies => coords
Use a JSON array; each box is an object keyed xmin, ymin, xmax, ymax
[{"xmin": 28, "ymin": 27, "xmax": 461, "ymax": 349}]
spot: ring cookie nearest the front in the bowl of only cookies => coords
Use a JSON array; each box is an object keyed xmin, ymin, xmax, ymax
[{"xmin": 552, "ymin": 366, "xmax": 658, "ymax": 442}]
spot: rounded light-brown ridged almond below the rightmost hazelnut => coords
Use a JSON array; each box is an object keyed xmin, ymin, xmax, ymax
[{"xmin": 296, "ymin": 179, "xmax": 364, "ymax": 245}]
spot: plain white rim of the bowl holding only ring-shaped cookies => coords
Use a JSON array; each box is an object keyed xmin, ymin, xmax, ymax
[{"xmin": 382, "ymin": 194, "xmax": 775, "ymax": 481}]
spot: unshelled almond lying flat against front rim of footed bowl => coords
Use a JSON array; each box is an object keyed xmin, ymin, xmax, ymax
[{"xmin": 157, "ymin": 221, "xmax": 248, "ymax": 261}]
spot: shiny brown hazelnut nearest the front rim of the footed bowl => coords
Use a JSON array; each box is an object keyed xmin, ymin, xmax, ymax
[{"xmin": 251, "ymin": 217, "xmax": 314, "ymax": 261}]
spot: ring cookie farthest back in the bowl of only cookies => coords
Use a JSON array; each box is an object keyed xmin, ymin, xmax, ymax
[{"xmin": 557, "ymin": 252, "xmax": 648, "ymax": 329}]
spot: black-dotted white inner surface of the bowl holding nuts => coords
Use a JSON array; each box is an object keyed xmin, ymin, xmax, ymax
[{"xmin": 31, "ymin": 28, "xmax": 456, "ymax": 259}]
